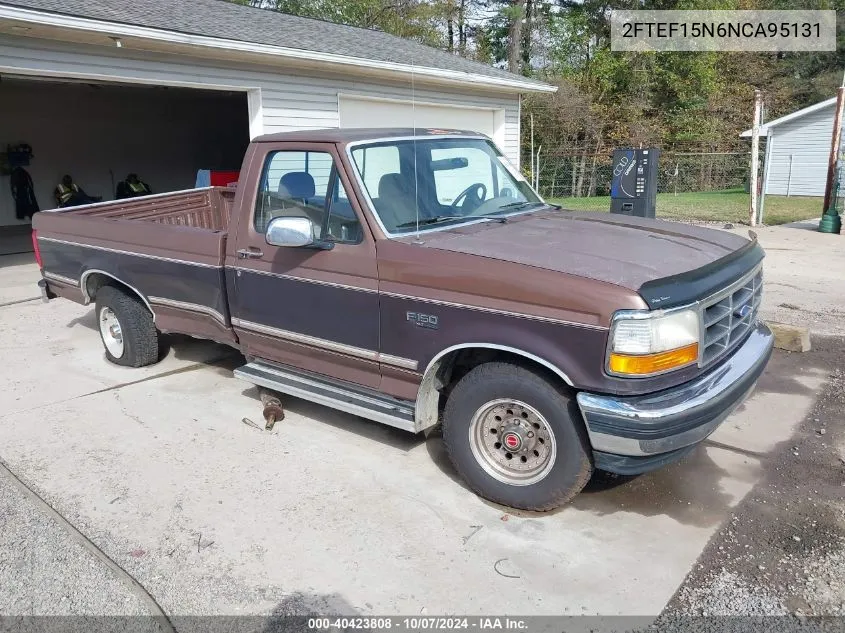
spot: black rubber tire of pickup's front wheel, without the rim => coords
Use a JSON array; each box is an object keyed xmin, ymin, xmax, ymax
[{"xmin": 443, "ymin": 362, "xmax": 593, "ymax": 511}]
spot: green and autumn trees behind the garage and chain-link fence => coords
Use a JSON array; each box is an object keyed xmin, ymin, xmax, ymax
[{"xmin": 226, "ymin": 0, "xmax": 845, "ymax": 190}]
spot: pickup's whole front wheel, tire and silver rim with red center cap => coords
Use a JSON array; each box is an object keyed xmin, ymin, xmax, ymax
[{"xmin": 443, "ymin": 362, "xmax": 592, "ymax": 511}]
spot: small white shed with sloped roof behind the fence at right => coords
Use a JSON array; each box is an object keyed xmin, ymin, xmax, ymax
[{"xmin": 741, "ymin": 97, "xmax": 836, "ymax": 196}]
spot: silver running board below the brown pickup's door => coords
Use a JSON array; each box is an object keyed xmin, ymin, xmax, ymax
[{"xmin": 234, "ymin": 360, "xmax": 417, "ymax": 433}]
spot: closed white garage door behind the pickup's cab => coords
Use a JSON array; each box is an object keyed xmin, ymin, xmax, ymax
[{"xmin": 340, "ymin": 95, "xmax": 505, "ymax": 147}]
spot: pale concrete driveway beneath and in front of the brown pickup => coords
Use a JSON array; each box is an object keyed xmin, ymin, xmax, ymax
[{"xmin": 0, "ymin": 221, "xmax": 845, "ymax": 616}]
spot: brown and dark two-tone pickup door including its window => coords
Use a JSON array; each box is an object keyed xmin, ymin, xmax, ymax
[{"xmin": 227, "ymin": 143, "xmax": 380, "ymax": 388}]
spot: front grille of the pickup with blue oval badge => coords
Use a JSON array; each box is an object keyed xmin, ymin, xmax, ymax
[{"xmin": 700, "ymin": 267, "xmax": 763, "ymax": 367}]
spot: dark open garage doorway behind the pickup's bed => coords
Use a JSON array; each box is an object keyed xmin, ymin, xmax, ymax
[{"xmin": 0, "ymin": 75, "xmax": 250, "ymax": 255}]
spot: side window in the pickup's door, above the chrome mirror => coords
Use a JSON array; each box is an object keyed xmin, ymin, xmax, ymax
[{"xmin": 253, "ymin": 150, "xmax": 362, "ymax": 243}]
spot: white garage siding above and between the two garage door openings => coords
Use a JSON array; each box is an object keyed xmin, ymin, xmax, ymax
[{"xmin": 0, "ymin": 36, "xmax": 519, "ymax": 164}]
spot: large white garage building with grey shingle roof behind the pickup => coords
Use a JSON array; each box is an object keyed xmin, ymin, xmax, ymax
[{"xmin": 0, "ymin": 0, "xmax": 555, "ymax": 253}]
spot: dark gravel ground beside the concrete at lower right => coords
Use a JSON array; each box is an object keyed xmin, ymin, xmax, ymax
[{"xmin": 657, "ymin": 337, "xmax": 845, "ymax": 631}]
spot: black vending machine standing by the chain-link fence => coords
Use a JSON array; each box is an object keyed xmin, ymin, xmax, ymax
[{"xmin": 610, "ymin": 147, "xmax": 660, "ymax": 218}]
